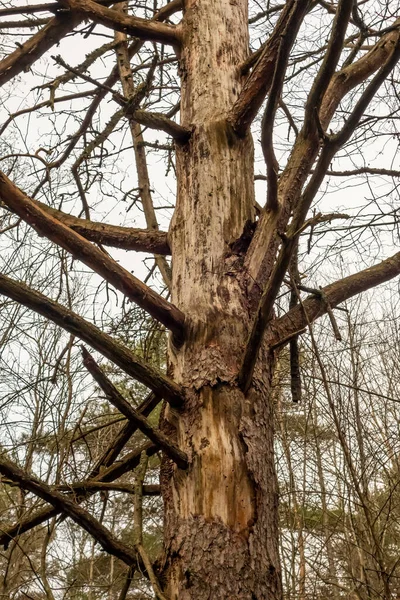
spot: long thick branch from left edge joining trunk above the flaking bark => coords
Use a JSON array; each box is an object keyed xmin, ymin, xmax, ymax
[{"xmin": 0, "ymin": 173, "xmax": 184, "ymax": 340}]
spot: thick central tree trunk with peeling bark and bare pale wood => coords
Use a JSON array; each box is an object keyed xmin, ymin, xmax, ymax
[{"xmin": 162, "ymin": 0, "xmax": 281, "ymax": 600}]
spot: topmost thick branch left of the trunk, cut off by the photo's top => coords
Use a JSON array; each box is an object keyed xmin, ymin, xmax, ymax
[{"xmin": 61, "ymin": 0, "xmax": 180, "ymax": 45}]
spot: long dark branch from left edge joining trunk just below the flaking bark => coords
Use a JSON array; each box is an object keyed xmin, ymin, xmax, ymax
[{"xmin": 0, "ymin": 275, "xmax": 183, "ymax": 406}]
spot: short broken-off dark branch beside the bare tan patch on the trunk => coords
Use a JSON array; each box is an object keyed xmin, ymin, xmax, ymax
[{"xmin": 82, "ymin": 348, "xmax": 188, "ymax": 469}]
